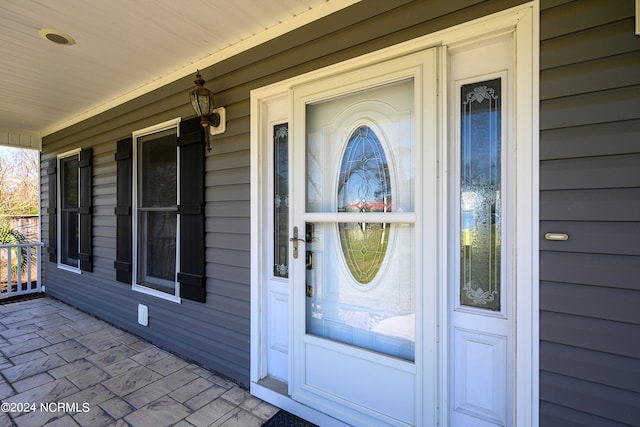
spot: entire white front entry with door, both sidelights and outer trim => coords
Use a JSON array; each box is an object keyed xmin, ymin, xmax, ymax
[{"xmin": 251, "ymin": 6, "xmax": 537, "ymax": 426}]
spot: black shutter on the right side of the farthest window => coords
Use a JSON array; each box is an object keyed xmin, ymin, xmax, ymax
[{"xmin": 78, "ymin": 148, "xmax": 93, "ymax": 271}]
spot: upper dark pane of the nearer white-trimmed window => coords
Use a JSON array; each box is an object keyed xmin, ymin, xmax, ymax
[{"xmin": 138, "ymin": 134, "xmax": 178, "ymax": 208}]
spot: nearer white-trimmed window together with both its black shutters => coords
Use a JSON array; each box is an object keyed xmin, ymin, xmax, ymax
[{"xmin": 115, "ymin": 117, "xmax": 207, "ymax": 302}]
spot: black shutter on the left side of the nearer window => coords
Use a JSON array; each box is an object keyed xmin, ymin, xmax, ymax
[{"xmin": 114, "ymin": 138, "xmax": 133, "ymax": 284}]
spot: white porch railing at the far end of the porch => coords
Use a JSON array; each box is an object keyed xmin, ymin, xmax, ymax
[{"xmin": 0, "ymin": 243, "xmax": 42, "ymax": 299}]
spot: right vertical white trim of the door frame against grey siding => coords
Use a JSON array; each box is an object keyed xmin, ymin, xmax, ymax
[{"xmin": 515, "ymin": 5, "xmax": 540, "ymax": 426}]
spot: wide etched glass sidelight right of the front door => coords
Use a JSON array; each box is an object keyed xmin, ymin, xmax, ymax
[{"xmin": 460, "ymin": 78, "xmax": 502, "ymax": 311}]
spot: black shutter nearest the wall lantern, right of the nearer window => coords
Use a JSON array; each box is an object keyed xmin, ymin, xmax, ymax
[{"xmin": 178, "ymin": 118, "xmax": 206, "ymax": 302}]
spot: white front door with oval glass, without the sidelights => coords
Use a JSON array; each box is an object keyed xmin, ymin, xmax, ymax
[{"xmin": 290, "ymin": 49, "xmax": 437, "ymax": 425}]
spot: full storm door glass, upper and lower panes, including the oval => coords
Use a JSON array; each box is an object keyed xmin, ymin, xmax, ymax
[{"xmin": 304, "ymin": 79, "xmax": 416, "ymax": 361}]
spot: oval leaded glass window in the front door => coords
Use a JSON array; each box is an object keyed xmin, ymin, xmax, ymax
[{"xmin": 337, "ymin": 126, "xmax": 391, "ymax": 285}]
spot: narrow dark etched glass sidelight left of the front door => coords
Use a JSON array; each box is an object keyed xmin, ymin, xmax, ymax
[{"xmin": 273, "ymin": 123, "xmax": 289, "ymax": 277}]
